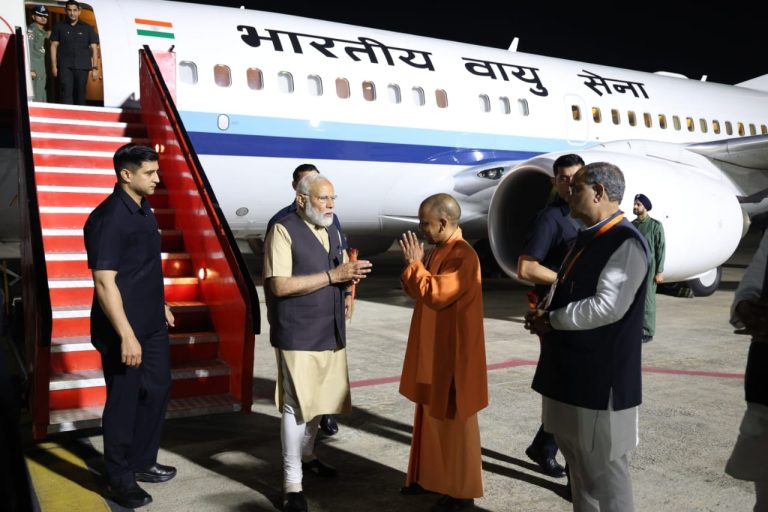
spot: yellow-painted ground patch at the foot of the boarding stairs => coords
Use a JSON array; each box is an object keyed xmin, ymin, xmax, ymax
[{"xmin": 26, "ymin": 443, "xmax": 110, "ymax": 512}]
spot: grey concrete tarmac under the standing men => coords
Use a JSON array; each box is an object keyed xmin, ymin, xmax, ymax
[{"xmin": 18, "ymin": 229, "xmax": 759, "ymax": 512}]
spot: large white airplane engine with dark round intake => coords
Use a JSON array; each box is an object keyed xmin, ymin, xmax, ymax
[{"xmin": 488, "ymin": 148, "xmax": 748, "ymax": 294}]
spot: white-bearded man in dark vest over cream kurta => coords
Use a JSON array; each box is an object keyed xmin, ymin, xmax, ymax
[{"xmin": 264, "ymin": 173, "xmax": 371, "ymax": 512}]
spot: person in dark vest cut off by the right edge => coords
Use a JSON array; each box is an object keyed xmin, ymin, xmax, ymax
[{"xmin": 725, "ymin": 226, "xmax": 768, "ymax": 512}]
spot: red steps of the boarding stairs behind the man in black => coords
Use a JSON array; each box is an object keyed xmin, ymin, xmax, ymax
[{"xmin": 29, "ymin": 103, "xmax": 241, "ymax": 433}]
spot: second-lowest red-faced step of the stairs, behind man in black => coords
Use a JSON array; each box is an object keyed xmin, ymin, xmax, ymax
[{"xmin": 51, "ymin": 332, "xmax": 219, "ymax": 374}]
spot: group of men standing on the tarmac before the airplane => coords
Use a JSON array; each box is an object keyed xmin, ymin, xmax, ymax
[{"xmin": 84, "ymin": 144, "xmax": 768, "ymax": 512}]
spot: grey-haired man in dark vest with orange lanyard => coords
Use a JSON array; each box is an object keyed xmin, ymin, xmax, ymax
[{"xmin": 525, "ymin": 162, "xmax": 648, "ymax": 512}]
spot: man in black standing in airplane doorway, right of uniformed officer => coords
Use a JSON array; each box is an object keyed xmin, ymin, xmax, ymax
[{"xmin": 51, "ymin": 0, "xmax": 99, "ymax": 105}]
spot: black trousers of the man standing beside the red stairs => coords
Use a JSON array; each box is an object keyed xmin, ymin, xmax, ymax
[{"xmin": 97, "ymin": 329, "xmax": 171, "ymax": 487}]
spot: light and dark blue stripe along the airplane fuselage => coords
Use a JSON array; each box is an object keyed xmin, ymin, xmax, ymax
[{"xmin": 181, "ymin": 112, "xmax": 567, "ymax": 165}]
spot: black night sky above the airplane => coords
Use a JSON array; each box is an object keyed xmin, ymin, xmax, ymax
[{"xmin": 171, "ymin": 0, "xmax": 768, "ymax": 84}]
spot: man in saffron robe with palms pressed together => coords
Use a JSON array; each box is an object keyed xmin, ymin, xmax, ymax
[{"xmin": 400, "ymin": 194, "xmax": 488, "ymax": 512}]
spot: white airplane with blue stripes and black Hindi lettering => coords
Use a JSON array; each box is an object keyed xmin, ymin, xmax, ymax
[{"xmin": 0, "ymin": 0, "xmax": 768, "ymax": 295}]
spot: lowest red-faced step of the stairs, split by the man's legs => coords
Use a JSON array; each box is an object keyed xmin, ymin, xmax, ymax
[{"xmin": 49, "ymin": 360, "xmax": 230, "ymax": 411}]
